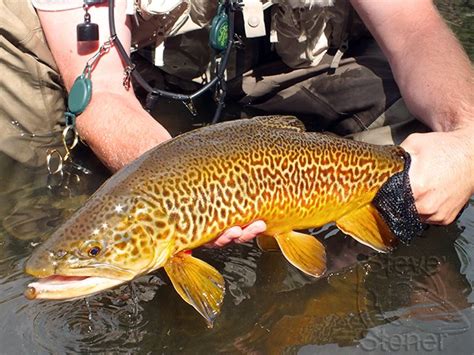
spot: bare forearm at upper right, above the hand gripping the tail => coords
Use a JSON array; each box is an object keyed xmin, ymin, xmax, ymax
[{"xmin": 351, "ymin": 0, "xmax": 474, "ymax": 131}]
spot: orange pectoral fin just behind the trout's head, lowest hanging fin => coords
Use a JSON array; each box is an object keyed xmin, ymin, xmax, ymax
[{"xmin": 164, "ymin": 252, "xmax": 225, "ymax": 328}]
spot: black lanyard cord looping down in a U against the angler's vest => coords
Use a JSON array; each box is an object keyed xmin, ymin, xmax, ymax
[{"xmin": 108, "ymin": 0, "xmax": 240, "ymax": 123}]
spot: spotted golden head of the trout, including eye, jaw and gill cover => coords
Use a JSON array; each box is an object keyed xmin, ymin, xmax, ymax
[{"xmin": 25, "ymin": 194, "xmax": 167, "ymax": 299}]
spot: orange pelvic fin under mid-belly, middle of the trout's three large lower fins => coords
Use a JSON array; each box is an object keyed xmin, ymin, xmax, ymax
[{"xmin": 275, "ymin": 232, "xmax": 326, "ymax": 277}]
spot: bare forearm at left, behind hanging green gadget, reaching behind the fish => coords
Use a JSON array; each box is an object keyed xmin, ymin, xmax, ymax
[{"xmin": 38, "ymin": 1, "xmax": 170, "ymax": 170}]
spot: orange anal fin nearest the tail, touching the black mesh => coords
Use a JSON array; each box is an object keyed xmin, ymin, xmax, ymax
[{"xmin": 336, "ymin": 203, "xmax": 397, "ymax": 253}]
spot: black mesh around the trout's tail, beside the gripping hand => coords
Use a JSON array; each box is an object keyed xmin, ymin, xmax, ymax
[{"xmin": 372, "ymin": 153, "xmax": 424, "ymax": 244}]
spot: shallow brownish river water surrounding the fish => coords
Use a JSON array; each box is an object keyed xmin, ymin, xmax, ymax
[{"xmin": 0, "ymin": 1, "xmax": 474, "ymax": 354}]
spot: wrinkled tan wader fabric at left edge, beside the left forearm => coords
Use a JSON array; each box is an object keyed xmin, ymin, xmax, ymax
[{"xmin": 0, "ymin": 0, "xmax": 65, "ymax": 166}]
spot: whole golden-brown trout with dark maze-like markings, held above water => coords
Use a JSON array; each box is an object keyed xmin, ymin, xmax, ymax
[{"xmin": 25, "ymin": 116, "xmax": 405, "ymax": 325}]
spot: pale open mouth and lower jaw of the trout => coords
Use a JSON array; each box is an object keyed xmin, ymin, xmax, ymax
[{"xmin": 24, "ymin": 275, "xmax": 126, "ymax": 300}]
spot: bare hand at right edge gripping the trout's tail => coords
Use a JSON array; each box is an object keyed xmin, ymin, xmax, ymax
[{"xmin": 401, "ymin": 127, "xmax": 474, "ymax": 224}]
